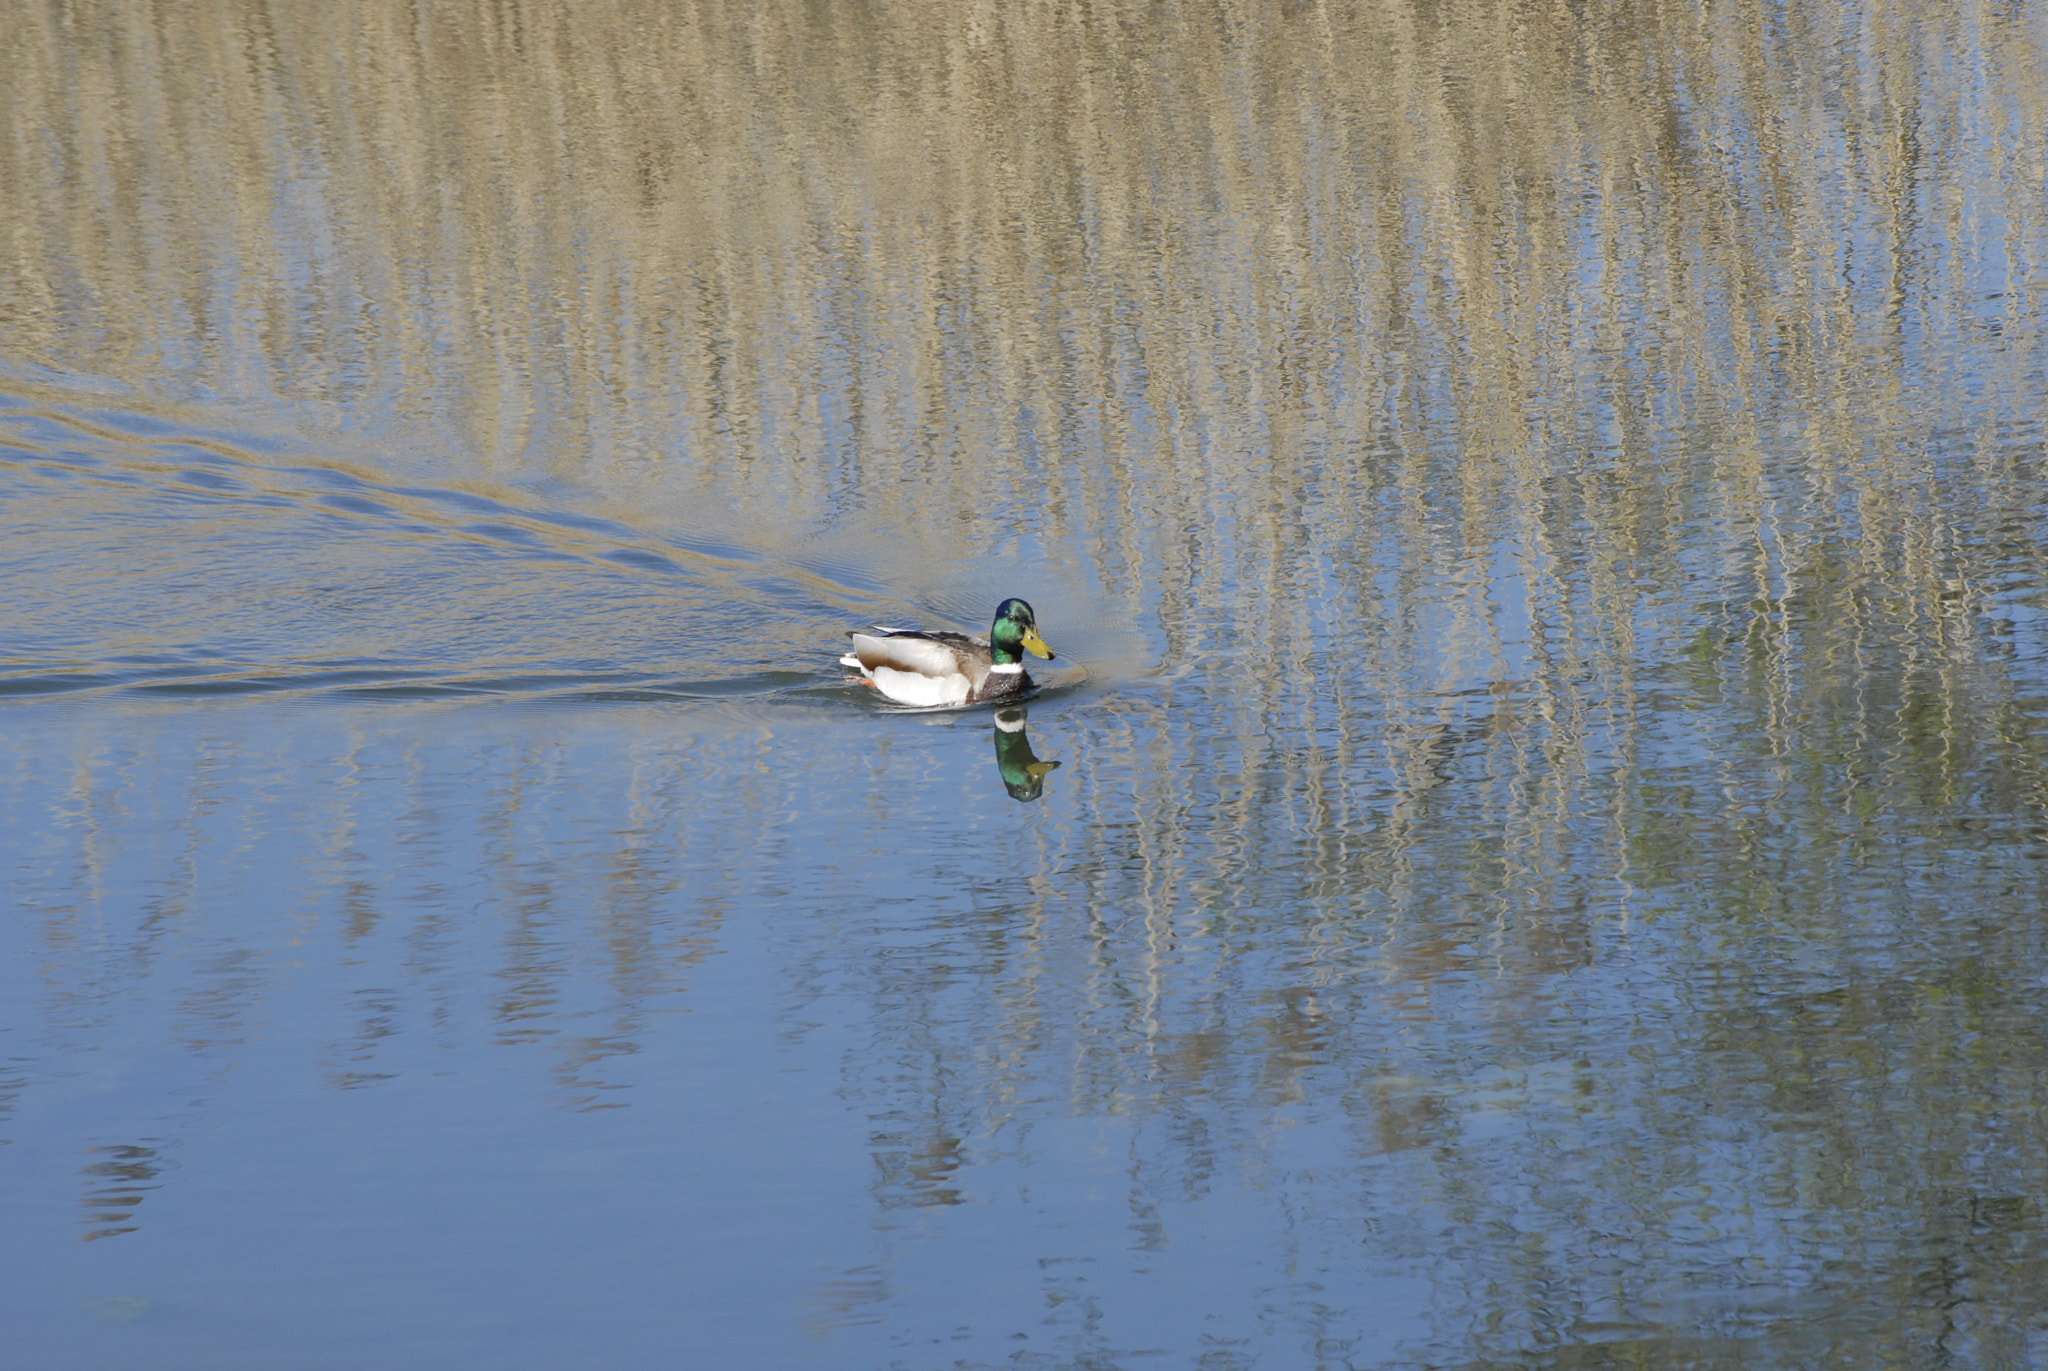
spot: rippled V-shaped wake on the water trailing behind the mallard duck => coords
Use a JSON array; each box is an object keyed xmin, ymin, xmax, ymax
[{"xmin": 0, "ymin": 389, "xmax": 1122, "ymax": 713}]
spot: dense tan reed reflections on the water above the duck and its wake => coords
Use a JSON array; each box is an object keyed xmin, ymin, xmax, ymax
[{"xmin": 0, "ymin": 2, "xmax": 2048, "ymax": 717}]
